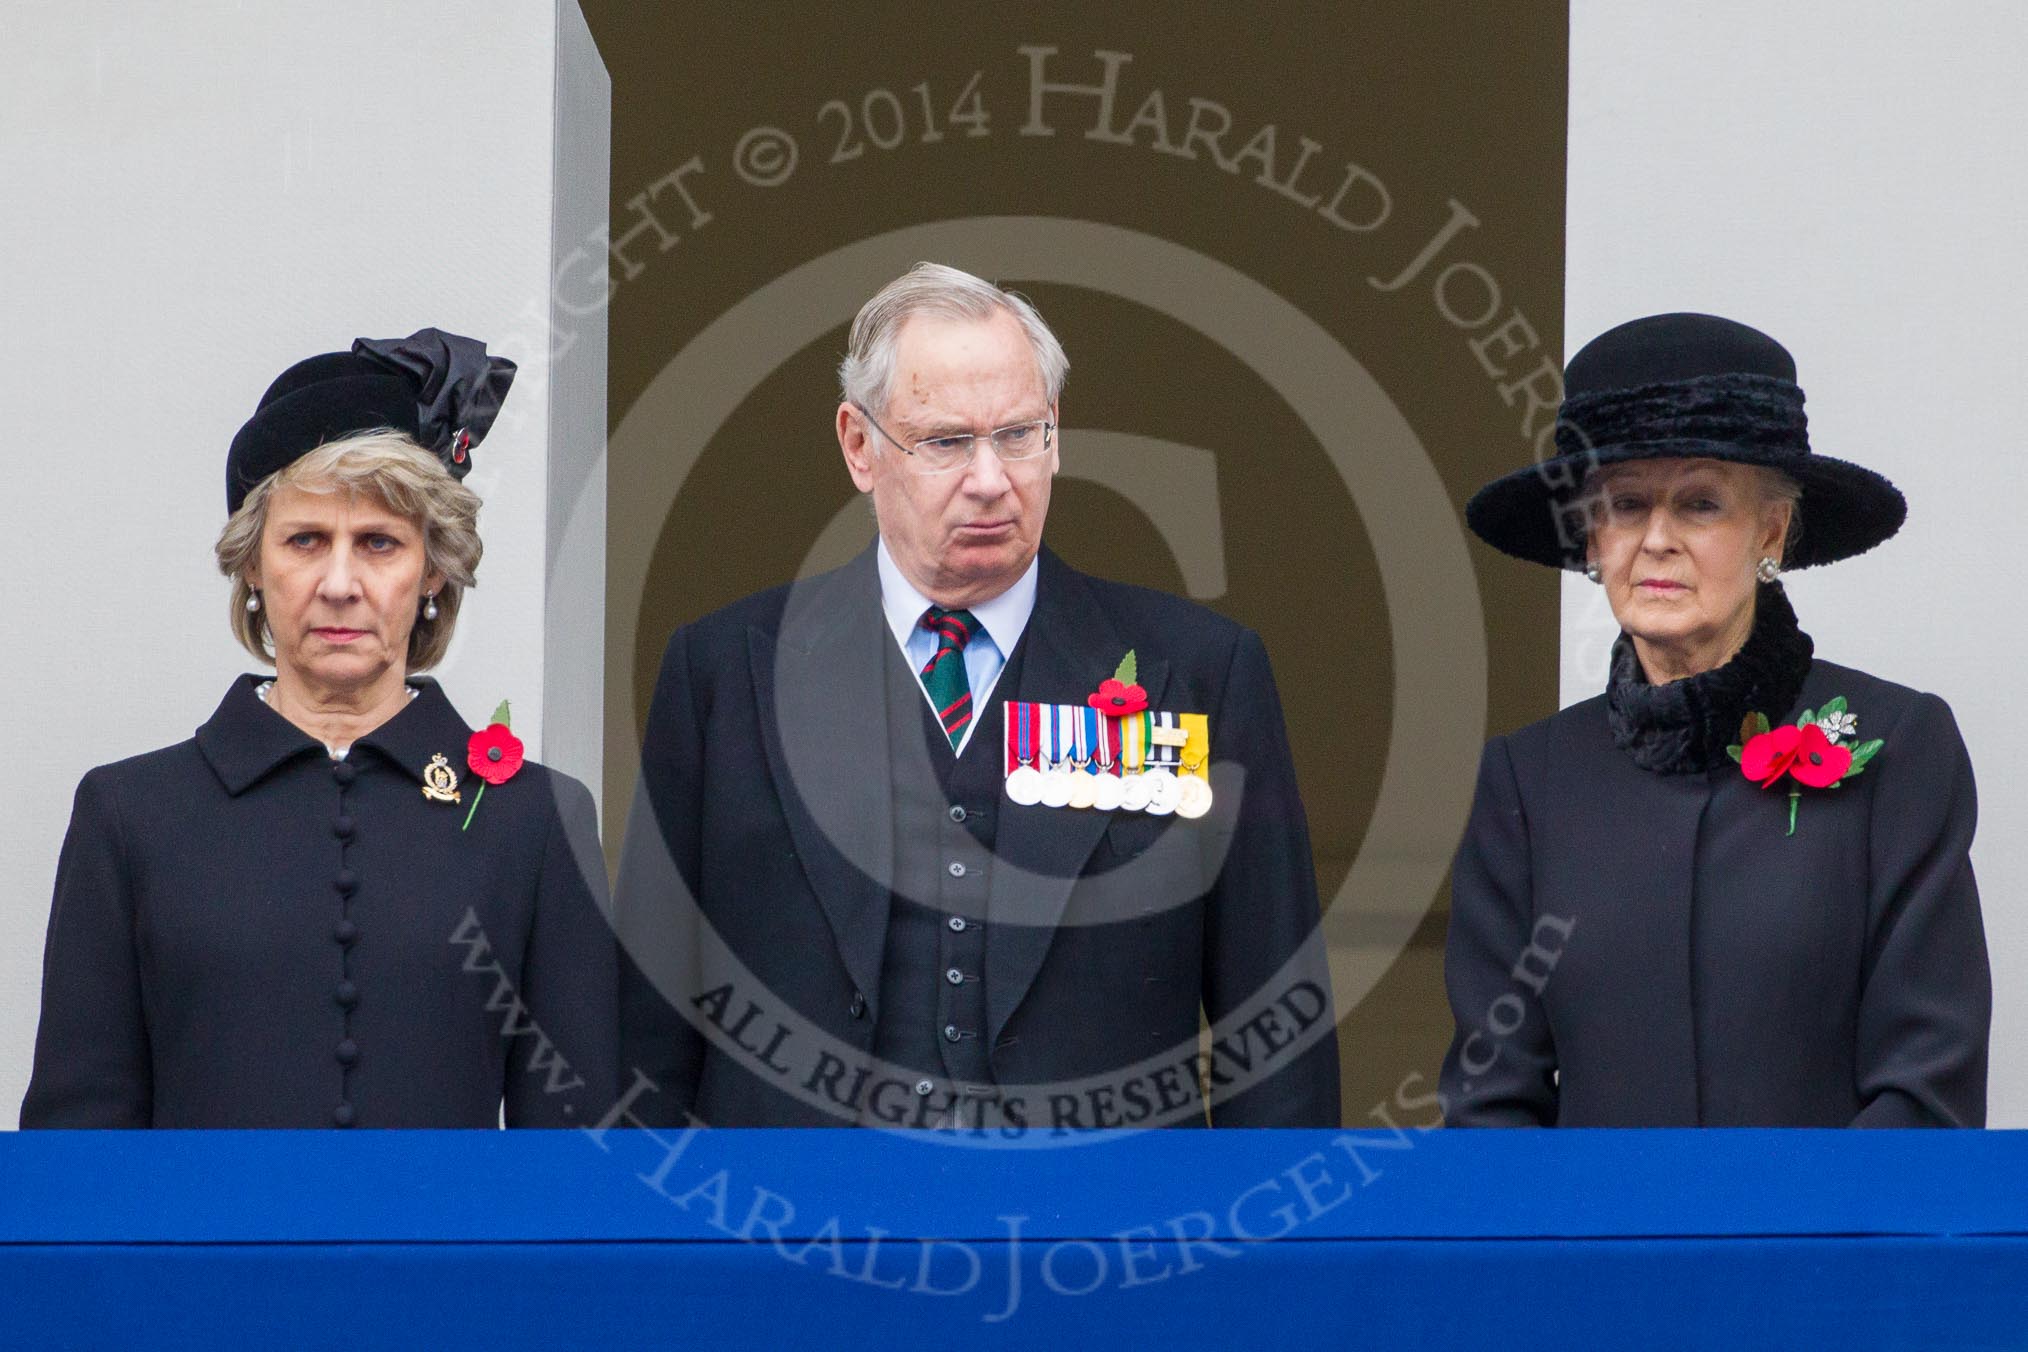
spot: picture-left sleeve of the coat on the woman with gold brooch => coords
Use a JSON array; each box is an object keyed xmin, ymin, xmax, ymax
[{"xmin": 20, "ymin": 770, "xmax": 154, "ymax": 1127}]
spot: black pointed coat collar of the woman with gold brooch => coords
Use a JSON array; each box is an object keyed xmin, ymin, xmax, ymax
[{"xmin": 197, "ymin": 675, "xmax": 473, "ymax": 797}]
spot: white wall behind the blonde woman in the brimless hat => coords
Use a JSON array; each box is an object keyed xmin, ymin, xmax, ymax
[{"xmin": 0, "ymin": 0, "xmax": 608, "ymax": 1125}]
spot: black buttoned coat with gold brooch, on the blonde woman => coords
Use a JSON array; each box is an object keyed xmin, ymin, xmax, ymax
[{"xmin": 20, "ymin": 677, "xmax": 617, "ymax": 1127}]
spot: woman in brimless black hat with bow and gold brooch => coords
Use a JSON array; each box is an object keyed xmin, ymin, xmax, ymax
[{"xmin": 20, "ymin": 328, "xmax": 617, "ymax": 1127}]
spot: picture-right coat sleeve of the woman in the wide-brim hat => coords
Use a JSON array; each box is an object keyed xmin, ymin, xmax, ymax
[{"xmin": 1854, "ymin": 695, "xmax": 1994, "ymax": 1127}]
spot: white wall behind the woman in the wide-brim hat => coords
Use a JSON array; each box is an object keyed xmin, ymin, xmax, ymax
[{"xmin": 1564, "ymin": 0, "xmax": 2028, "ymax": 1127}]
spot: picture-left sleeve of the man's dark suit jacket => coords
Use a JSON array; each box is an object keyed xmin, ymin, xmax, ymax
[{"xmin": 617, "ymin": 628, "xmax": 706, "ymax": 1127}]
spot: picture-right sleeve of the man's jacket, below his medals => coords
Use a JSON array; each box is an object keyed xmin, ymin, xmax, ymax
[{"xmin": 1203, "ymin": 630, "xmax": 1341, "ymax": 1127}]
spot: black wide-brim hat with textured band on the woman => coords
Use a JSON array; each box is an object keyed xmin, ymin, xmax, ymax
[{"xmin": 1464, "ymin": 314, "xmax": 1908, "ymax": 570}]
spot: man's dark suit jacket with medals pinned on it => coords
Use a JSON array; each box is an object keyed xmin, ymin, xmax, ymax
[{"xmin": 619, "ymin": 549, "xmax": 1338, "ymax": 1127}]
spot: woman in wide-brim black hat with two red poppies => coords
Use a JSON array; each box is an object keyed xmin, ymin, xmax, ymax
[{"xmin": 1442, "ymin": 314, "xmax": 1991, "ymax": 1127}]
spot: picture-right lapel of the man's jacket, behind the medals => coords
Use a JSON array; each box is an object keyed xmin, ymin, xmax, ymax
[{"xmin": 977, "ymin": 549, "xmax": 1168, "ymax": 1040}]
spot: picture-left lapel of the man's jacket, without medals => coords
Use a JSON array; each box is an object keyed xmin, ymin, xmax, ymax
[{"xmin": 746, "ymin": 549, "xmax": 894, "ymax": 1001}]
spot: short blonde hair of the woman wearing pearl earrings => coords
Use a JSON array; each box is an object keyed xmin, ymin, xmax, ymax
[{"xmin": 217, "ymin": 428, "xmax": 485, "ymax": 671}]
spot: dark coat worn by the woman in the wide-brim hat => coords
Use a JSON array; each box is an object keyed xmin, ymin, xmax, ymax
[{"xmin": 1442, "ymin": 661, "xmax": 1991, "ymax": 1127}]
